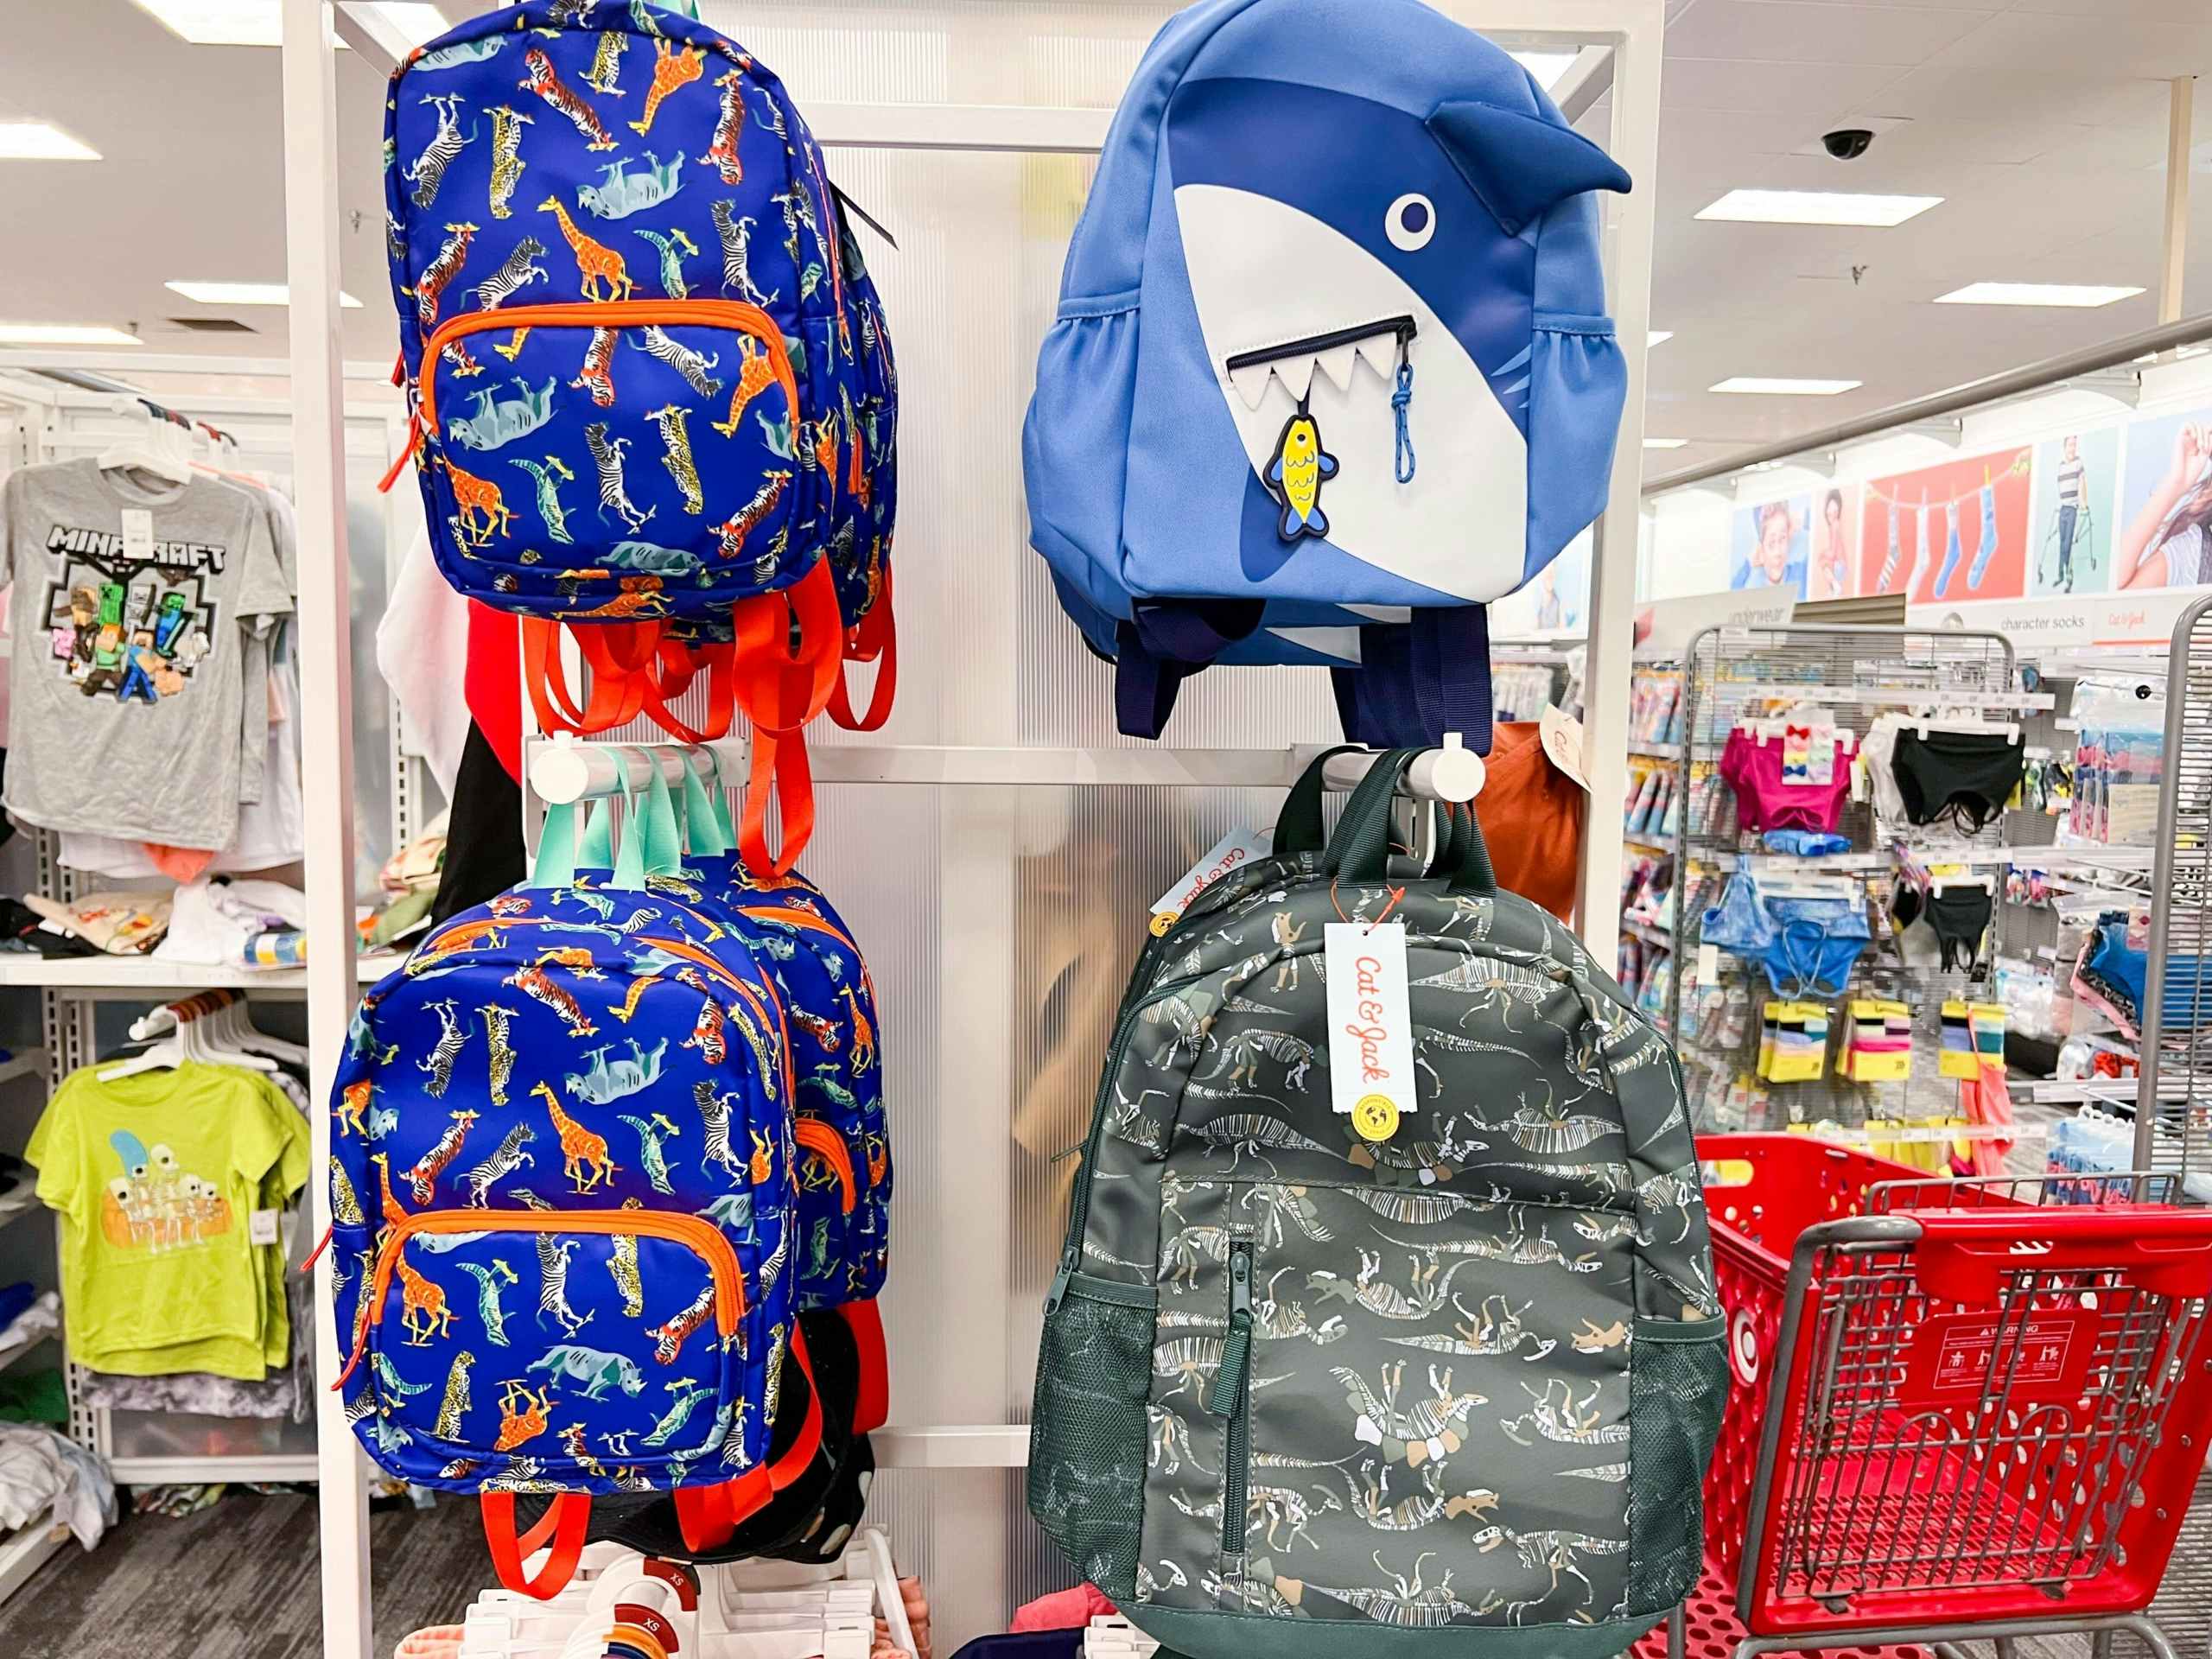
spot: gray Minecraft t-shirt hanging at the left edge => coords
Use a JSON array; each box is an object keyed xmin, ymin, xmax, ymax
[{"xmin": 0, "ymin": 460, "xmax": 292, "ymax": 847}]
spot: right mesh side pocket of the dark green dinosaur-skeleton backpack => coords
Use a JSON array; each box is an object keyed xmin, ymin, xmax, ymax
[{"xmin": 1628, "ymin": 1319, "xmax": 1727, "ymax": 1615}]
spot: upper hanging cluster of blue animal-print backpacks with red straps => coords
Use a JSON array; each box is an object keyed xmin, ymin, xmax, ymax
[{"xmin": 385, "ymin": 0, "xmax": 898, "ymax": 868}]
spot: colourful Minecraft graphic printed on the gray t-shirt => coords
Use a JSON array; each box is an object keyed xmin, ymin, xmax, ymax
[{"xmin": 47, "ymin": 524, "xmax": 228, "ymax": 703}]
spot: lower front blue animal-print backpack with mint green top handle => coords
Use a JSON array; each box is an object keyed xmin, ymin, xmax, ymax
[{"xmin": 329, "ymin": 790, "xmax": 831, "ymax": 1595}]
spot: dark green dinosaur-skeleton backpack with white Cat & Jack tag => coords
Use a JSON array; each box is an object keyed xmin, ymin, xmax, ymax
[{"xmin": 1028, "ymin": 750, "xmax": 1727, "ymax": 1659}]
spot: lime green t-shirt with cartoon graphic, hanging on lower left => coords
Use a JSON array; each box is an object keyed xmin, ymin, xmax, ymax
[{"xmin": 24, "ymin": 1062, "xmax": 309, "ymax": 1382}]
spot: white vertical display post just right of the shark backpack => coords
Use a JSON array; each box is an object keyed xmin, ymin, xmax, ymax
[{"xmin": 1574, "ymin": 0, "xmax": 1666, "ymax": 964}]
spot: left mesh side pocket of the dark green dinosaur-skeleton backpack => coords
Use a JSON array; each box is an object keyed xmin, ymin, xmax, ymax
[{"xmin": 1028, "ymin": 1279, "xmax": 1153, "ymax": 1604}]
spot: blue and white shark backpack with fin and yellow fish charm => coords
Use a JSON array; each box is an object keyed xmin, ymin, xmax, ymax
[{"xmin": 1024, "ymin": 0, "xmax": 1628, "ymax": 750}]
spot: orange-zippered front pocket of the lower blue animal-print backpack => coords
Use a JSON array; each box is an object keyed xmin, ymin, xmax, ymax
[{"xmin": 363, "ymin": 1210, "xmax": 766, "ymax": 1491}]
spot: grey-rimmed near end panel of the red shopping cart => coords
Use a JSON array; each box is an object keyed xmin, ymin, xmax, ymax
[{"xmin": 1738, "ymin": 1205, "xmax": 2212, "ymax": 1635}]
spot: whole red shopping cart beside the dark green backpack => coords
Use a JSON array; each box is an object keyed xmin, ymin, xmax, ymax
[{"xmin": 1637, "ymin": 1135, "xmax": 2212, "ymax": 1659}]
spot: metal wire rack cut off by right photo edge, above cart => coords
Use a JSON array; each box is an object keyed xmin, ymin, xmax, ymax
[{"xmin": 2134, "ymin": 597, "xmax": 2212, "ymax": 1173}]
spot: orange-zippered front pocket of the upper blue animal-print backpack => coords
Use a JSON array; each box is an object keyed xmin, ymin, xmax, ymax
[{"xmin": 418, "ymin": 301, "xmax": 804, "ymax": 621}]
